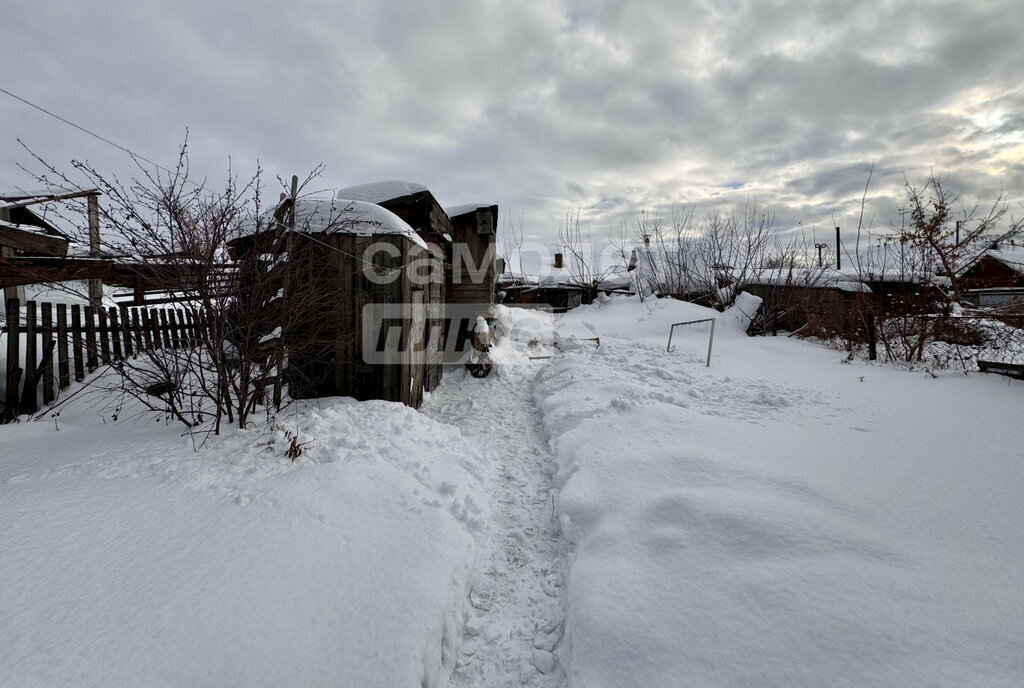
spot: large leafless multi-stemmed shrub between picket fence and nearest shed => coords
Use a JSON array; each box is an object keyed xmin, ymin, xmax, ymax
[{"xmin": 25, "ymin": 142, "xmax": 348, "ymax": 433}]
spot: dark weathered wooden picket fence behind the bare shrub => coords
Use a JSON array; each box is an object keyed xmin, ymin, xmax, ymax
[{"xmin": 0, "ymin": 299, "xmax": 206, "ymax": 423}]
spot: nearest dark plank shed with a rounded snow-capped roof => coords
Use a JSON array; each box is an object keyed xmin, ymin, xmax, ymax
[{"xmin": 230, "ymin": 199, "xmax": 444, "ymax": 407}]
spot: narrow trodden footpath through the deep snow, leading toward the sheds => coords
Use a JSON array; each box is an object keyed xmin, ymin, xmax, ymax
[{"xmin": 421, "ymin": 363, "xmax": 567, "ymax": 688}]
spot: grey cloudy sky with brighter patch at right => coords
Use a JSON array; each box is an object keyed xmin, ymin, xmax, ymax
[{"xmin": 0, "ymin": 0, "xmax": 1024, "ymax": 254}]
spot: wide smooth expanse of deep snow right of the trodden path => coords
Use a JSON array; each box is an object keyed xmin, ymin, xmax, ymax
[{"xmin": 536, "ymin": 299, "xmax": 1024, "ymax": 687}]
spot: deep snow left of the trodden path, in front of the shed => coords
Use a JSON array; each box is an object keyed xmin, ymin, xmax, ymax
[{"xmin": 0, "ymin": 400, "xmax": 488, "ymax": 688}]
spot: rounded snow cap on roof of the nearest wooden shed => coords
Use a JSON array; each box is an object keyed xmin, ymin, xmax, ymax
[{"xmin": 280, "ymin": 199, "xmax": 427, "ymax": 249}]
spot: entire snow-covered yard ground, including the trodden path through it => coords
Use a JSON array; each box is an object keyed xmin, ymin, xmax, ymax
[{"xmin": 0, "ymin": 299, "xmax": 1024, "ymax": 688}]
